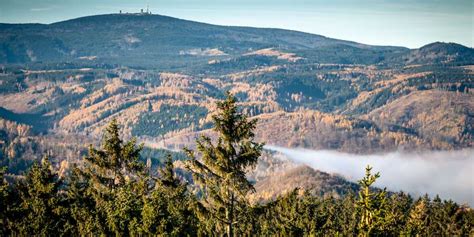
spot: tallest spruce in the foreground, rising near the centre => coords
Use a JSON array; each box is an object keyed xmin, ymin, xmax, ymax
[{"xmin": 185, "ymin": 92, "xmax": 263, "ymax": 237}]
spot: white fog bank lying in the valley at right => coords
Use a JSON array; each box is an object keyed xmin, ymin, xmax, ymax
[{"xmin": 265, "ymin": 146, "xmax": 474, "ymax": 207}]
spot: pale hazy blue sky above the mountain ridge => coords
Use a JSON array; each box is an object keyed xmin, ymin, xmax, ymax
[{"xmin": 0, "ymin": 0, "xmax": 474, "ymax": 48}]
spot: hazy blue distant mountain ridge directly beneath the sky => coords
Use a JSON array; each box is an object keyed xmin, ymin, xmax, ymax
[{"xmin": 0, "ymin": 14, "xmax": 474, "ymax": 68}]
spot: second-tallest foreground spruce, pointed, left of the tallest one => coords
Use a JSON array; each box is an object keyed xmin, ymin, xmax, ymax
[{"xmin": 75, "ymin": 119, "xmax": 144, "ymax": 234}]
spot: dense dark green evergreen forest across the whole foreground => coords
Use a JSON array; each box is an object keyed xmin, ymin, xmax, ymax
[{"xmin": 0, "ymin": 94, "xmax": 474, "ymax": 236}]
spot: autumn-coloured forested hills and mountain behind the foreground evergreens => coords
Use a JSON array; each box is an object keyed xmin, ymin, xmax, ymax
[{"xmin": 0, "ymin": 14, "xmax": 474, "ymax": 203}]
